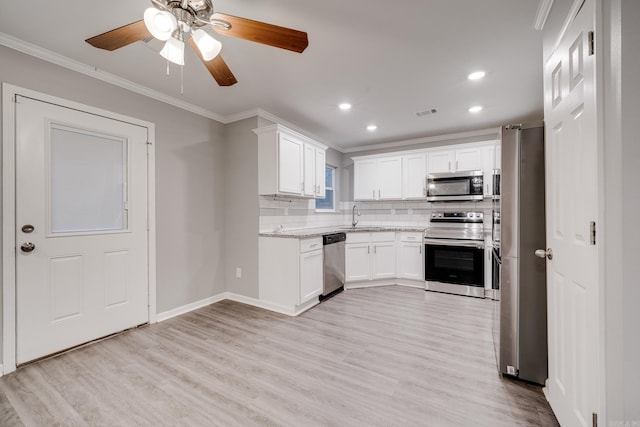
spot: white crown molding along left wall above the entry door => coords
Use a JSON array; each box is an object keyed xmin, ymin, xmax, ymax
[{"xmin": 0, "ymin": 32, "xmax": 224, "ymax": 123}]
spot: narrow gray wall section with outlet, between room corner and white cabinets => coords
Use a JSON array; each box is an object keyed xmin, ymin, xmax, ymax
[{"xmin": 225, "ymin": 117, "xmax": 260, "ymax": 298}]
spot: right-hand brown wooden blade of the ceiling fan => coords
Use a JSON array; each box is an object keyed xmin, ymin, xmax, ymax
[{"xmin": 212, "ymin": 13, "xmax": 309, "ymax": 53}]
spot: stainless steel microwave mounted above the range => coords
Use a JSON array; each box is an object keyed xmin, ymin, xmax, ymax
[{"xmin": 427, "ymin": 170, "xmax": 484, "ymax": 202}]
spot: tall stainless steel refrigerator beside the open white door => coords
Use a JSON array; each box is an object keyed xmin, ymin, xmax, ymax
[{"xmin": 494, "ymin": 122, "xmax": 548, "ymax": 384}]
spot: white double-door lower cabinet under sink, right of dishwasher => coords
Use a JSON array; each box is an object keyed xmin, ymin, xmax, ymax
[{"xmin": 345, "ymin": 231, "xmax": 396, "ymax": 282}]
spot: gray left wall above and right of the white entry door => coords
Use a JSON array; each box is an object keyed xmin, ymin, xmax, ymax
[{"xmin": 0, "ymin": 46, "xmax": 226, "ymax": 360}]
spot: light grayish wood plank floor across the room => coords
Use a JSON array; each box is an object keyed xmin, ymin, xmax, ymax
[{"xmin": 0, "ymin": 286, "xmax": 557, "ymax": 427}]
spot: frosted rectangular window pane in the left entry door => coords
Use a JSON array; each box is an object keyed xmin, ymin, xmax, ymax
[{"xmin": 50, "ymin": 124, "xmax": 127, "ymax": 233}]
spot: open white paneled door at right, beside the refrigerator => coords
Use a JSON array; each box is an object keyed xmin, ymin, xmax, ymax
[{"xmin": 544, "ymin": 0, "xmax": 601, "ymax": 426}]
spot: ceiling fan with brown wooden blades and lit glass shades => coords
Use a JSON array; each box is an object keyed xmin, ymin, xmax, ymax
[{"xmin": 86, "ymin": 0, "xmax": 309, "ymax": 86}]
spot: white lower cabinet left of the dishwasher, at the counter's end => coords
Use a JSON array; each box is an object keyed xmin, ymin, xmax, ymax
[{"xmin": 258, "ymin": 237, "xmax": 324, "ymax": 315}]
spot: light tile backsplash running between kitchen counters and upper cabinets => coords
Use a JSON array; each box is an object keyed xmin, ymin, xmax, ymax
[{"xmin": 260, "ymin": 196, "xmax": 492, "ymax": 232}]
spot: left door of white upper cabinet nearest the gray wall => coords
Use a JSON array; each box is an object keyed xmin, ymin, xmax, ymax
[{"xmin": 278, "ymin": 133, "xmax": 304, "ymax": 194}]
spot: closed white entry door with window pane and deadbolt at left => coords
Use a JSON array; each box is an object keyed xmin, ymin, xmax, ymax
[{"xmin": 16, "ymin": 96, "xmax": 149, "ymax": 364}]
